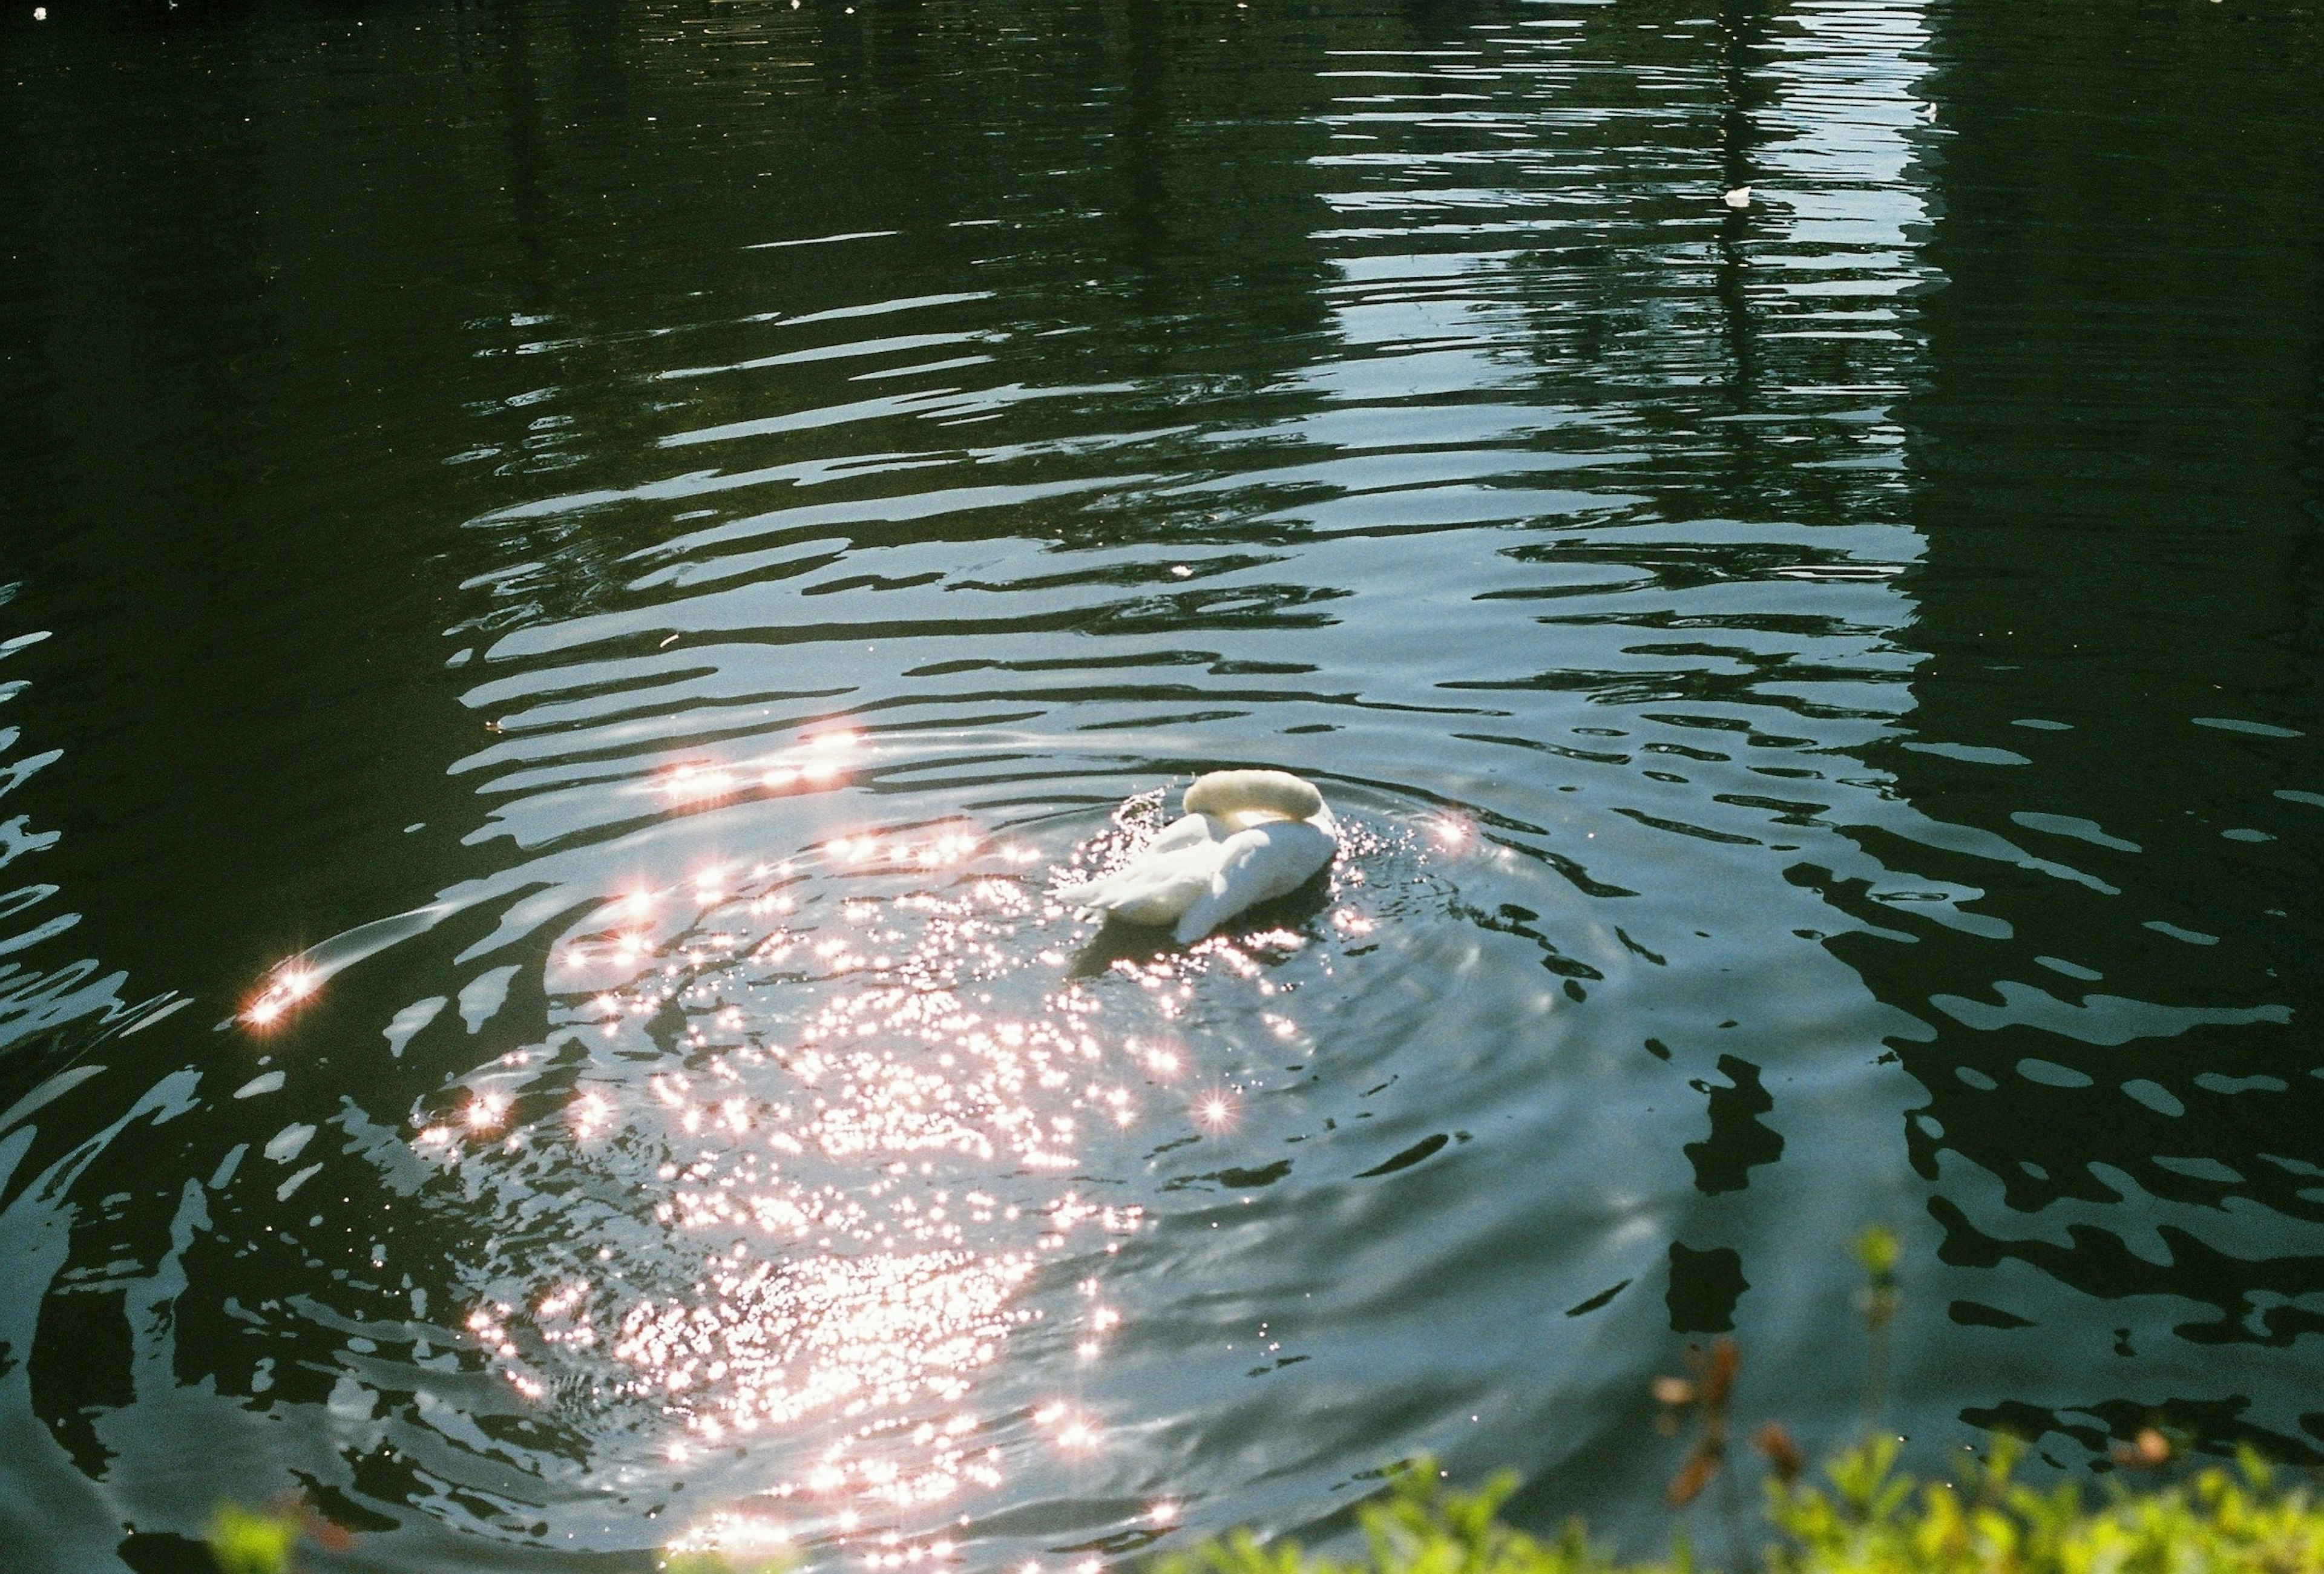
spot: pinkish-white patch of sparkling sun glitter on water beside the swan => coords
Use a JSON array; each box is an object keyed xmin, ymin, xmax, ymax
[{"xmin": 369, "ymin": 785, "xmax": 1431, "ymax": 1563}]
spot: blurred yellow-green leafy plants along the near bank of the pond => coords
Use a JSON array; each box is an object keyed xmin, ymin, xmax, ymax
[{"xmin": 207, "ymin": 1225, "xmax": 2324, "ymax": 1574}]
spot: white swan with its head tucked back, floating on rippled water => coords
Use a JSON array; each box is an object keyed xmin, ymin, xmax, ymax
[{"xmin": 1057, "ymin": 770, "xmax": 1339, "ymax": 944}]
